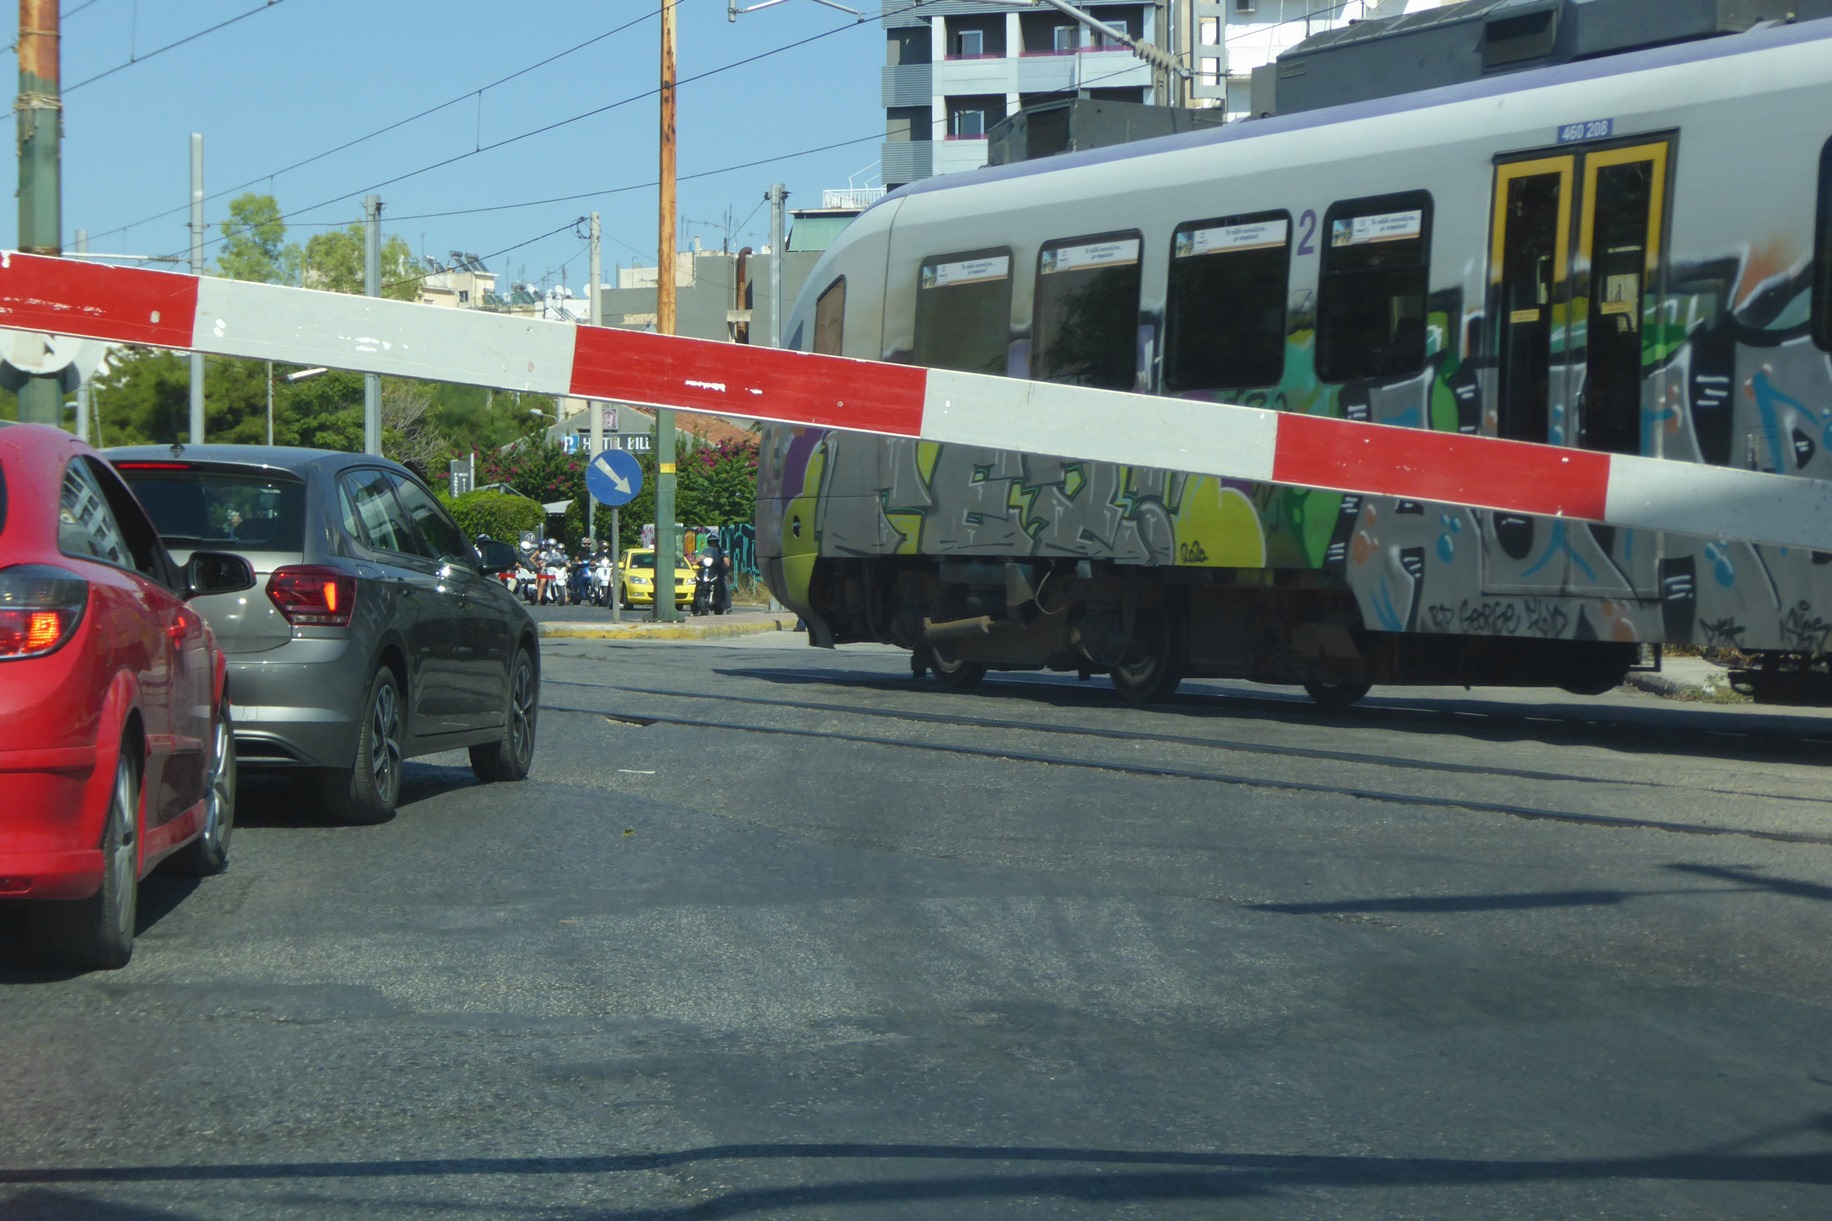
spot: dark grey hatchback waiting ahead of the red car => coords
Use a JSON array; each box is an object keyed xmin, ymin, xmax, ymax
[{"xmin": 104, "ymin": 446, "xmax": 540, "ymax": 823}]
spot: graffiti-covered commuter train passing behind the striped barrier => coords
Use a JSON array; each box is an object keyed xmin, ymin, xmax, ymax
[{"xmin": 757, "ymin": 18, "xmax": 1832, "ymax": 706}]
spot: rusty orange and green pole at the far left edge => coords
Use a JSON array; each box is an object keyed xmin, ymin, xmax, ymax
[{"xmin": 13, "ymin": 0, "xmax": 64, "ymax": 427}]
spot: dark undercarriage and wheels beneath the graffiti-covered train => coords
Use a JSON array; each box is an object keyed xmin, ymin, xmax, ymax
[{"xmin": 808, "ymin": 557, "xmax": 1641, "ymax": 708}]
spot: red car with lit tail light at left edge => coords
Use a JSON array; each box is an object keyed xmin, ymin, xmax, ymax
[{"xmin": 0, "ymin": 424, "xmax": 255, "ymax": 968}]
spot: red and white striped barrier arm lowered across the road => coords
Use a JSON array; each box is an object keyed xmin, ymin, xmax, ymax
[{"xmin": 0, "ymin": 253, "xmax": 1832, "ymax": 552}]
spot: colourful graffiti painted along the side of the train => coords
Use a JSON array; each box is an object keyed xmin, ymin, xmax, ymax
[{"xmin": 771, "ymin": 253, "xmax": 1832, "ymax": 651}]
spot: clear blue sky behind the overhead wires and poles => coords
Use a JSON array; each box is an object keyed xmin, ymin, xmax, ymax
[{"xmin": 5, "ymin": 0, "xmax": 883, "ymax": 292}]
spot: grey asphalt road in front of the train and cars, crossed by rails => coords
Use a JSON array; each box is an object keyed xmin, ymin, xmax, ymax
[{"xmin": 0, "ymin": 633, "xmax": 1832, "ymax": 1221}]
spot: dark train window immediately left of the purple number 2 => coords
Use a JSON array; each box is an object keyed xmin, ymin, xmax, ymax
[{"xmin": 1163, "ymin": 213, "xmax": 1292, "ymax": 394}]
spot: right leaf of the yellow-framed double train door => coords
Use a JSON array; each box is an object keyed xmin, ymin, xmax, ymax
[{"xmin": 1576, "ymin": 143, "xmax": 1667, "ymax": 453}]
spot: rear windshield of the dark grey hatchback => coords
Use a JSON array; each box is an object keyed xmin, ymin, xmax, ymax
[{"xmin": 117, "ymin": 462, "xmax": 306, "ymax": 552}]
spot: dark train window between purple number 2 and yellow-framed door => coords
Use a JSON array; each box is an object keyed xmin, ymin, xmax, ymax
[{"xmin": 1317, "ymin": 191, "xmax": 1431, "ymax": 381}]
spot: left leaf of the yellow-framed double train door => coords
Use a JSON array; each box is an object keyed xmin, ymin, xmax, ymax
[{"xmin": 1489, "ymin": 156, "xmax": 1576, "ymax": 442}]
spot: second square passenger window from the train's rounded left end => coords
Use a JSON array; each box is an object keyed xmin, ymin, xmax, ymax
[{"xmin": 1031, "ymin": 231, "xmax": 1143, "ymax": 391}]
